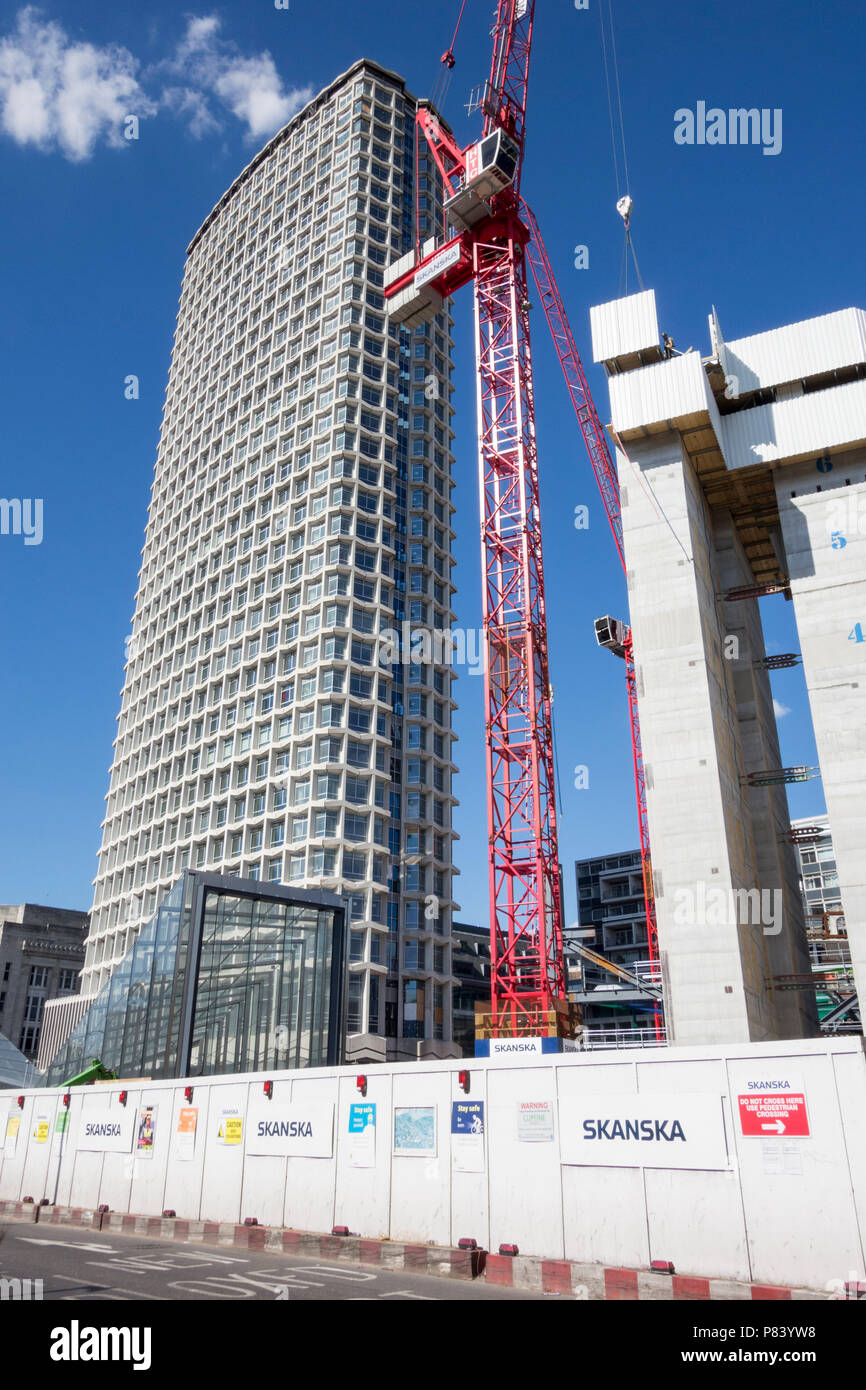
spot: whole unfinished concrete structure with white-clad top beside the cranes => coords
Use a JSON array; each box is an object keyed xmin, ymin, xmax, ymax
[{"xmin": 592, "ymin": 291, "xmax": 866, "ymax": 1044}]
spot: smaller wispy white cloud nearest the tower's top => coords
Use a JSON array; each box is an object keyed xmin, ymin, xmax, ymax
[{"xmin": 161, "ymin": 15, "xmax": 313, "ymax": 139}]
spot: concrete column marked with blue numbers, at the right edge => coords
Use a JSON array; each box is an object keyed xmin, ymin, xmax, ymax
[{"xmin": 776, "ymin": 449, "xmax": 866, "ymax": 1023}]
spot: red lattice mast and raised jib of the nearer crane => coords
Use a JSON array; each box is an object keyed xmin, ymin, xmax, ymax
[{"xmin": 467, "ymin": 0, "xmax": 566, "ymax": 1036}]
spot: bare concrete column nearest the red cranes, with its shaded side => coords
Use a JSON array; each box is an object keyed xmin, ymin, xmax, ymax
[{"xmin": 619, "ymin": 432, "xmax": 808, "ymax": 1044}]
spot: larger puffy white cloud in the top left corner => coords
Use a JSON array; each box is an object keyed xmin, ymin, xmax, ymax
[{"xmin": 0, "ymin": 6, "xmax": 156, "ymax": 161}]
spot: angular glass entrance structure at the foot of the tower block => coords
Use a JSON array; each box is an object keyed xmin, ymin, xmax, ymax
[{"xmin": 46, "ymin": 873, "xmax": 345, "ymax": 1086}]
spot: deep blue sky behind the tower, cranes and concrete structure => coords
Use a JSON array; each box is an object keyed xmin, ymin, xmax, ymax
[{"xmin": 0, "ymin": 0, "xmax": 866, "ymax": 922}]
